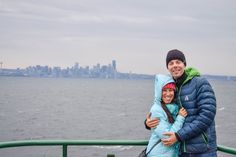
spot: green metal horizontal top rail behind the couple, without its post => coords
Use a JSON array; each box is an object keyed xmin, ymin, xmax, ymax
[{"xmin": 0, "ymin": 140, "xmax": 236, "ymax": 155}]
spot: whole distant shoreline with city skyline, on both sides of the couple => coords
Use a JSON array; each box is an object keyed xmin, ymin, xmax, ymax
[{"xmin": 0, "ymin": 60, "xmax": 236, "ymax": 78}]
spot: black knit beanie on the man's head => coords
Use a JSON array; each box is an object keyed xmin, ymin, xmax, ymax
[{"xmin": 166, "ymin": 49, "xmax": 186, "ymax": 68}]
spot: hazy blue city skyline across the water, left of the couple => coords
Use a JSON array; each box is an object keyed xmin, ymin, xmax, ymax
[{"xmin": 0, "ymin": 60, "xmax": 154, "ymax": 79}]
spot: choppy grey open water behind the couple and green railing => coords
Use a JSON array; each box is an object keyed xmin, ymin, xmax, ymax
[{"xmin": 0, "ymin": 77, "xmax": 236, "ymax": 157}]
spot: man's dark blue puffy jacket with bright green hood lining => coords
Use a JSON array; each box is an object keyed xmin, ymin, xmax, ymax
[{"xmin": 177, "ymin": 68, "xmax": 217, "ymax": 153}]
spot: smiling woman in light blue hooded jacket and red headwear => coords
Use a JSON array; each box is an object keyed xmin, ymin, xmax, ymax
[{"xmin": 146, "ymin": 75, "xmax": 187, "ymax": 157}]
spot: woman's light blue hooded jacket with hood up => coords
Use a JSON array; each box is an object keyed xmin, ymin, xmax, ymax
[{"xmin": 146, "ymin": 75, "xmax": 185, "ymax": 157}]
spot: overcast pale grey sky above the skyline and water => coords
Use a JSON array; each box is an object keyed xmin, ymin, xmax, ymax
[{"xmin": 0, "ymin": 0, "xmax": 236, "ymax": 75}]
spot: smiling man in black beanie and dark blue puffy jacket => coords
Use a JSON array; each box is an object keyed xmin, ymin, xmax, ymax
[{"xmin": 145, "ymin": 49, "xmax": 217, "ymax": 157}]
